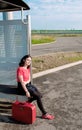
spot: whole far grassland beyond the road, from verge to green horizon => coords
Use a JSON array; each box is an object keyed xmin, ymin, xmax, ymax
[{"xmin": 32, "ymin": 30, "xmax": 82, "ymax": 44}]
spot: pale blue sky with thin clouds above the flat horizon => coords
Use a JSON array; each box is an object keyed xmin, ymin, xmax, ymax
[{"xmin": 0, "ymin": 0, "xmax": 82, "ymax": 30}]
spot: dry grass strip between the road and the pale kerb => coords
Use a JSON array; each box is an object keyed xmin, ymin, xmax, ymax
[{"xmin": 32, "ymin": 52, "xmax": 82, "ymax": 73}]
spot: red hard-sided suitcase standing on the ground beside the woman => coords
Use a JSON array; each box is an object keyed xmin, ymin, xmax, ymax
[{"xmin": 12, "ymin": 101, "xmax": 36, "ymax": 124}]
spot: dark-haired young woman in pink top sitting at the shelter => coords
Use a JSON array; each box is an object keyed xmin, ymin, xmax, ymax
[{"xmin": 17, "ymin": 55, "xmax": 54, "ymax": 120}]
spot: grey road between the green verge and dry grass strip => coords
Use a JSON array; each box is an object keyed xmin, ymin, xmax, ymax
[{"xmin": 31, "ymin": 37, "xmax": 82, "ymax": 56}]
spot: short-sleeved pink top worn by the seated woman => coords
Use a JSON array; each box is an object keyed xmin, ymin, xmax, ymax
[{"xmin": 17, "ymin": 67, "xmax": 30, "ymax": 82}]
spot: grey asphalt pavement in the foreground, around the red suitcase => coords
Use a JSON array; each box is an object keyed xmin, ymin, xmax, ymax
[{"xmin": 0, "ymin": 63, "xmax": 82, "ymax": 130}]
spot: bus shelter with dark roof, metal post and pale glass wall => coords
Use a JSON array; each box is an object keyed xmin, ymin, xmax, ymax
[{"xmin": 0, "ymin": 0, "xmax": 31, "ymax": 85}]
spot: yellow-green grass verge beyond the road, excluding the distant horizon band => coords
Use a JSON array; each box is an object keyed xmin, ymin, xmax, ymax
[{"xmin": 32, "ymin": 33, "xmax": 82, "ymax": 44}]
